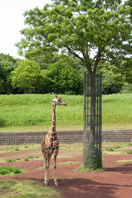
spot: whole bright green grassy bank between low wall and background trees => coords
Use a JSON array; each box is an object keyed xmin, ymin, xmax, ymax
[{"xmin": 0, "ymin": 94, "xmax": 132, "ymax": 132}]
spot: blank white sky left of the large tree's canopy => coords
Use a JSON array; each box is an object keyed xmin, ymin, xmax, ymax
[{"xmin": 0, "ymin": 0, "xmax": 51, "ymax": 58}]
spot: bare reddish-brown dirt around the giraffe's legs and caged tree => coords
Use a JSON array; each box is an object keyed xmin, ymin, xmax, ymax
[{"xmin": 0, "ymin": 144, "xmax": 132, "ymax": 198}]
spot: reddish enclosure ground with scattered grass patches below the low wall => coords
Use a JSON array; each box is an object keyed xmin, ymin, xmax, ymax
[{"xmin": 0, "ymin": 143, "xmax": 132, "ymax": 198}]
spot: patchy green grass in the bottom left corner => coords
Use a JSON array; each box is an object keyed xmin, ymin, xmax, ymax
[{"xmin": 0, "ymin": 179, "xmax": 61, "ymax": 198}]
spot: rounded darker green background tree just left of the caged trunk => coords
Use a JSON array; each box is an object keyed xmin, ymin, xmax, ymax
[{"xmin": 48, "ymin": 61, "xmax": 83, "ymax": 94}]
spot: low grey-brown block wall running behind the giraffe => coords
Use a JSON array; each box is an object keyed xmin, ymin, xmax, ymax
[{"xmin": 0, "ymin": 129, "xmax": 132, "ymax": 145}]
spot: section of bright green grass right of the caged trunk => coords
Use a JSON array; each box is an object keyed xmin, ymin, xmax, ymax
[{"xmin": 102, "ymin": 94, "xmax": 132, "ymax": 126}]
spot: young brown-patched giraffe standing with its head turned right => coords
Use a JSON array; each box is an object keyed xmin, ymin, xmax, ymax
[{"xmin": 41, "ymin": 96, "xmax": 67, "ymax": 186}]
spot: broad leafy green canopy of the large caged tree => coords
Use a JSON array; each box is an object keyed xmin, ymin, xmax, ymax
[{"xmin": 17, "ymin": 0, "xmax": 132, "ymax": 75}]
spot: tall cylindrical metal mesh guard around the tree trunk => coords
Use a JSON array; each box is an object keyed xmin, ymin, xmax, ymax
[{"xmin": 83, "ymin": 73, "xmax": 102, "ymax": 168}]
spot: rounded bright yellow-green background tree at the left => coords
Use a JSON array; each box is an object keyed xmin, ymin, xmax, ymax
[{"xmin": 11, "ymin": 60, "xmax": 40, "ymax": 93}]
